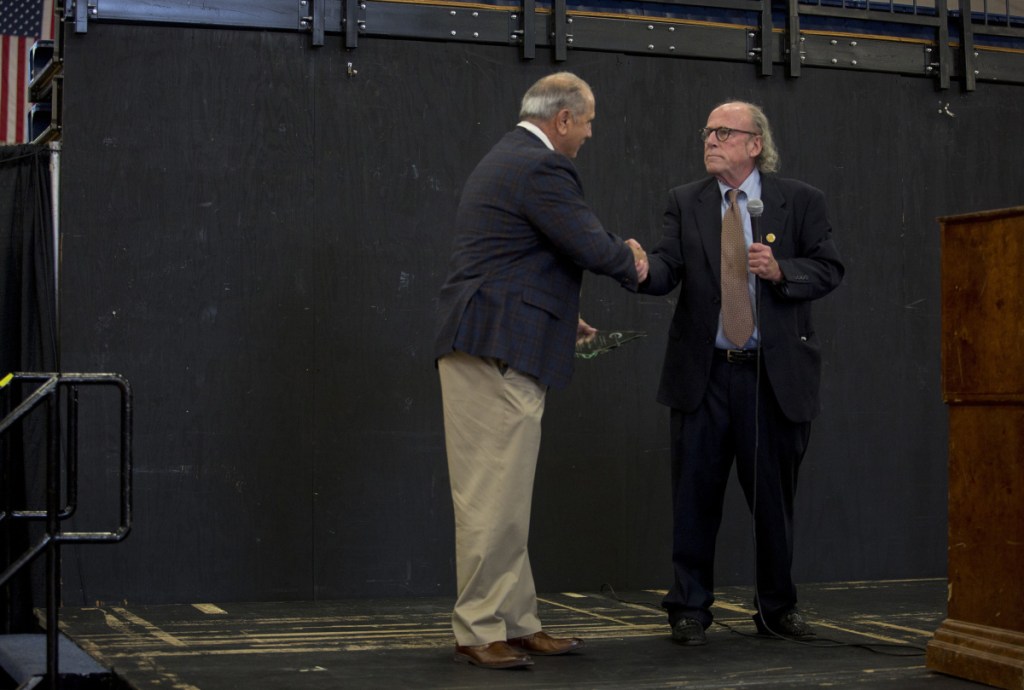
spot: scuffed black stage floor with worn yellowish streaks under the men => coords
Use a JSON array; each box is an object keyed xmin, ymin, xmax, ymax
[{"xmin": 61, "ymin": 579, "xmax": 985, "ymax": 690}]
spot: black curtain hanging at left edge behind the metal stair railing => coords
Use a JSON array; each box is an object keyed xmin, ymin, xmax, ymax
[{"xmin": 0, "ymin": 144, "xmax": 58, "ymax": 633}]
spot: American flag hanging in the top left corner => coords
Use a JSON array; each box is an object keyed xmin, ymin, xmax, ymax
[{"xmin": 0, "ymin": 0, "xmax": 54, "ymax": 143}]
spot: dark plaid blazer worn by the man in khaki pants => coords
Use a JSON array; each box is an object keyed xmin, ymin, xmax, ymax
[{"xmin": 434, "ymin": 127, "xmax": 637, "ymax": 387}]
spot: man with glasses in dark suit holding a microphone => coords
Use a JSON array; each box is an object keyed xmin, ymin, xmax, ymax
[{"xmin": 640, "ymin": 101, "xmax": 844, "ymax": 645}]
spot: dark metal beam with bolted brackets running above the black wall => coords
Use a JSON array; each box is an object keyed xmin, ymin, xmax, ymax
[{"xmin": 51, "ymin": 0, "xmax": 1024, "ymax": 85}]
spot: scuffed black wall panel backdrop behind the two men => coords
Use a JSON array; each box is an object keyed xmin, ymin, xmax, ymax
[{"xmin": 46, "ymin": 25, "xmax": 1024, "ymax": 605}]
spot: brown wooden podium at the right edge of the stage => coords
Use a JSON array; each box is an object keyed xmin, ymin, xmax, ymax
[{"xmin": 927, "ymin": 207, "xmax": 1024, "ymax": 690}]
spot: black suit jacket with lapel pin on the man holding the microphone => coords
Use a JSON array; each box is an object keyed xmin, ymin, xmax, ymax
[{"xmin": 640, "ymin": 175, "xmax": 845, "ymax": 422}]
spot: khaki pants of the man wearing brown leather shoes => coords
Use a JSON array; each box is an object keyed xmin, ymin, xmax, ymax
[{"xmin": 437, "ymin": 352, "xmax": 547, "ymax": 645}]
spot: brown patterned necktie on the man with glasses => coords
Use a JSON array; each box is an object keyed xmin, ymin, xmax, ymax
[{"xmin": 722, "ymin": 189, "xmax": 754, "ymax": 347}]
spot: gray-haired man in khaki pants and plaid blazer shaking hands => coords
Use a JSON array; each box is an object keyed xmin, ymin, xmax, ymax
[{"xmin": 434, "ymin": 72, "xmax": 647, "ymax": 669}]
